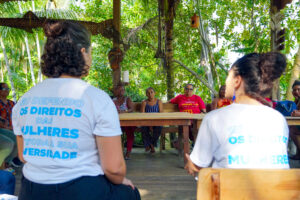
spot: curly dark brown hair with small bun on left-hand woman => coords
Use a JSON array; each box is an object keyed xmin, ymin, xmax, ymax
[{"xmin": 41, "ymin": 21, "xmax": 91, "ymax": 78}]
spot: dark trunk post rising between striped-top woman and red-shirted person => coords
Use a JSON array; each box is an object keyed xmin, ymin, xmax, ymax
[{"xmin": 164, "ymin": 0, "xmax": 179, "ymax": 100}]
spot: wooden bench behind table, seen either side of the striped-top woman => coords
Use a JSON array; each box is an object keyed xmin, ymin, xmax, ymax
[{"xmin": 133, "ymin": 102, "xmax": 179, "ymax": 152}]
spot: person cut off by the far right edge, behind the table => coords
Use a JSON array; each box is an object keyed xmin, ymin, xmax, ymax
[{"xmin": 289, "ymin": 80, "xmax": 300, "ymax": 160}]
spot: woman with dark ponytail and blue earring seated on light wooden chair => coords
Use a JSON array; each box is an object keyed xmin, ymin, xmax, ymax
[{"xmin": 185, "ymin": 53, "xmax": 289, "ymax": 175}]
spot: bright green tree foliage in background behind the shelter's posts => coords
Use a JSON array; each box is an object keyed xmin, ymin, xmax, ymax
[{"xmin": 0, "ymin": 0, "xmax": 300, "ymax": 102}]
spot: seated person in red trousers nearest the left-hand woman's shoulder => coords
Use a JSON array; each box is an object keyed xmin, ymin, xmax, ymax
[{"xmin": 113, "ymin": 84, "xmax": 136, "ymax": 160}]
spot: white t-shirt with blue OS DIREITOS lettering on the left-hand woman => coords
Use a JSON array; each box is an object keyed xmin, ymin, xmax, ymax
[{"xmin": 12, "ymin": 78, "xmax": 121, "ymax": 184}]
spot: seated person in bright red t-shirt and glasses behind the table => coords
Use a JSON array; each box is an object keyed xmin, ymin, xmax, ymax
[{"xmin": 170, "ymin": 84, "xmax": 206, "ymax": 141}]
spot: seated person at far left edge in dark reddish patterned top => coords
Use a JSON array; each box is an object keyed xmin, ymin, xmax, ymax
[{"xmin": 0, "ymin": 83, "xmax": 22, "ymax": 167}]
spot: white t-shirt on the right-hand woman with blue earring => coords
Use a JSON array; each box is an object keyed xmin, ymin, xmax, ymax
[{"xmin": 190, "ymin": 103, "xmax": 289, "ymax": 169}]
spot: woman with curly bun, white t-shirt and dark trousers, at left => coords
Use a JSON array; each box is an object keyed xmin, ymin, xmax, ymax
[{"xmin": 13, "ymin": 21, "xmax": 140, "ymax": 200}]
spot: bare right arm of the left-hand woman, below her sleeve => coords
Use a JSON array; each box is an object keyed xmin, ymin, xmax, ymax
[{"xmin": 96, "ymin": 136, "xmax": 126, "ymax": 184}]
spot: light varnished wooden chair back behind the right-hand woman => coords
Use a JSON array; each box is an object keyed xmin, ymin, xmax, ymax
[{"xmin": 197, "ymin": 168, "xmax": 300, "ymax": 200}]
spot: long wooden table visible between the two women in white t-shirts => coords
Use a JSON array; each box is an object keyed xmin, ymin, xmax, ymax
[{"xmin": 119, "ymin": 112, "xmax": 204, "ymax": 166}]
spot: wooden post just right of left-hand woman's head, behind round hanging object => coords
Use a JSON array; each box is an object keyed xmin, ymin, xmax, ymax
[{"xmin": 113, "ymin": 0, "xmax": 121, "ymax": 87}]
